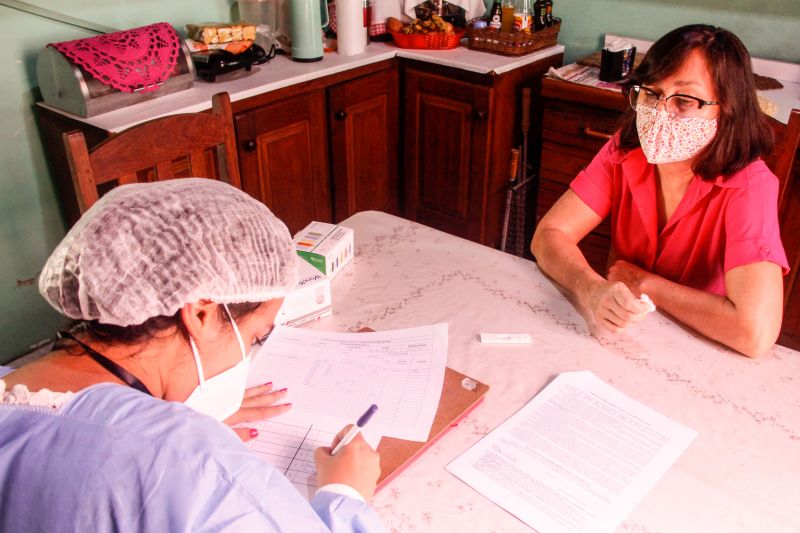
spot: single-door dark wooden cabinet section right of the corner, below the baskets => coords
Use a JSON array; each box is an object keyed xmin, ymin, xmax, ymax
[{"xmin": 402, "ymin": 55, "xmax": 562, "ymax": 248}]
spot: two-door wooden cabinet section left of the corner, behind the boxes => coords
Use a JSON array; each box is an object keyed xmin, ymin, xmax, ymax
[{"xmin": 234, "ymin": 61, "xmax": 400, "ymax": 233}]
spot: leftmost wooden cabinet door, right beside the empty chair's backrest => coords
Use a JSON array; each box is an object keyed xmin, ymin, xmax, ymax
[{"xmin": 234, "ymin": 91, "xmax": 332, "ymax": 233}]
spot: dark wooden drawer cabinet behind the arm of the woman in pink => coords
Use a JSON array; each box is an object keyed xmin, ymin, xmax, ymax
[{"xmin": 536, "ymin": 78, "xmax": 626, "ymax": 274}]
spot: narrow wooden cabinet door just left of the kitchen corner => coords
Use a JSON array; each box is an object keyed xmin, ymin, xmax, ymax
[{"xmin": 328, "ymin": 68, "xmax": 400, "ymax": 221}]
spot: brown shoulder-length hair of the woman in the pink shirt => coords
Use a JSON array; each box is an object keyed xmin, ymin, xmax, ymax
[{"xmin": 619, "ymin": 24, "xmax": 773, "ymax": 180}]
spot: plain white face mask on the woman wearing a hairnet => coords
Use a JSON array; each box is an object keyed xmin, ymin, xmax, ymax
[{"xmin": 183, "ymin": 305, "xmax": 250, "ymax": 421}]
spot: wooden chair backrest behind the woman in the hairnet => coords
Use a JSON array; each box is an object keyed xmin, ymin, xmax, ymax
[{"xmin": 63, "ymin": 93, "xmax": 241, "ymax": 213}]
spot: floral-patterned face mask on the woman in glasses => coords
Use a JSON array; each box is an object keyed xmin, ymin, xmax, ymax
[{"xmin": 636, "ymin": 105, "xmax": 717, "ymax": 165}]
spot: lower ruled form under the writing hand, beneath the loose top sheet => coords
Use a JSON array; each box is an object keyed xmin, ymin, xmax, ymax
[{"xmin": 247, "ymin": 420, "xmax": 380, "ymax": 500}]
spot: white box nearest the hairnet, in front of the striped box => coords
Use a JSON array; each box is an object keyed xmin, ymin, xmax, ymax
[{"xmin": 275, "ymin": 261, "xmax": 333, "ymax": 326}]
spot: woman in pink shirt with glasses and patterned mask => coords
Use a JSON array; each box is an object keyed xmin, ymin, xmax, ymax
[{"xmin": 531, "ymin": 25, "xmax": 788, "ymax": 357}]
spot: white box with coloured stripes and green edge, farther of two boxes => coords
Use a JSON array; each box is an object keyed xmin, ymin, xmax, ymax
[{"xmin": 294, "ymin": 222, "xmax": 353, "ymax": 279}]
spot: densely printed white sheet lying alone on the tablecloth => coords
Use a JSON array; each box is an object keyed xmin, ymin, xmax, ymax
[{"xmin": 447, "ymin": 372, "xmax": 696, "ymax": 533}]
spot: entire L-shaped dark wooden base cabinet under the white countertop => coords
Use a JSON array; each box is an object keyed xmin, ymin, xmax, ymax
[{"xmin": 39, "ymin": 54, "xmax": 563, "ymax": 251}]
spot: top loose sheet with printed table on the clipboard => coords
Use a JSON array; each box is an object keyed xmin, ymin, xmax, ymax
[{"xmin": 248, "ymin": 324, "xmax": 447, "ymax": 441}]
